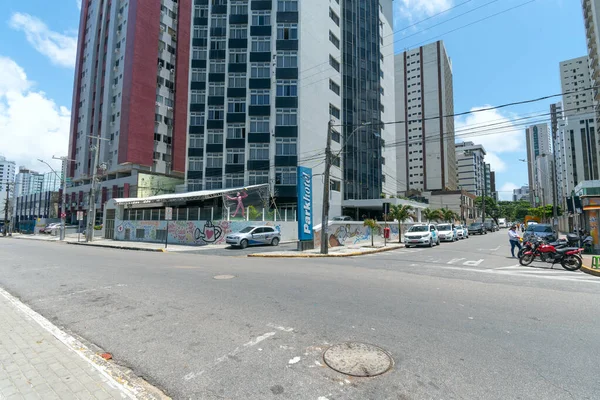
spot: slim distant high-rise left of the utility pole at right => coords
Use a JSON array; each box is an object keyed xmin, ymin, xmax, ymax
[{"xmin": 525, "ymin": 124, "xmax": 552, "ymax": 205}]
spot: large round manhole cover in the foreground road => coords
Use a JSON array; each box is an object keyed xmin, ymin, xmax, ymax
[{"xmin": 323, "ymin": 342, "xmax": 393, "ymax": 377}]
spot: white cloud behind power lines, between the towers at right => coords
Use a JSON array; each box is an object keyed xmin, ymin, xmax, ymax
[{"xmin": 454, "ymin": 105, "xmax": 525, "ymax": 172}]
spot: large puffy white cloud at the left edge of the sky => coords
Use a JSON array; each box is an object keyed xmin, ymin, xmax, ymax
[{"xmin": 0, "ymin": 56, "xmax": 71, "ymax": 171}]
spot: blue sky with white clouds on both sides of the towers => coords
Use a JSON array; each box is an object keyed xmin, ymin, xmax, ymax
[{"xmin": 0, "ymin": 0, "xmax": 586, "ymax": 197}]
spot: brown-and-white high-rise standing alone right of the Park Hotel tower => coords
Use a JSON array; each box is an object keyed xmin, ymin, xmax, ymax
[{"xmin": 395, "ymin": 41, "xmax": 458, "ymax": 193}]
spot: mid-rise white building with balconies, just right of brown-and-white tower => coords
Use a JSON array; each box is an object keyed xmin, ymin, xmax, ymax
[{"xmin": 455, "ymin": 142, "xmax": 491, "ymax": 197}]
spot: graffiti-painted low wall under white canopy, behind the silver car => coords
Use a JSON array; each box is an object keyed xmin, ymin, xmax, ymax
[{"xmin": 115, "ymin": 221, "xmax": 288, "ymax": 246}]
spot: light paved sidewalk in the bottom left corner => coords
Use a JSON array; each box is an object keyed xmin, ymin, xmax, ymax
[{"xmin": 0, "ymin": 291, "xmax": 135, "ymax": 400}]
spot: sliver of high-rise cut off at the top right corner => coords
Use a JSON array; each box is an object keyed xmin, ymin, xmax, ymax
[{"xmin": 581, "ymin": 0, "xmax": 600, "ymax": 103}]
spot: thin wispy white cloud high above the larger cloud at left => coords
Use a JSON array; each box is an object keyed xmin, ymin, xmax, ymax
[{"xmin": 9, "ymin": 13, "xmax": 77, "ymax": 68}]
